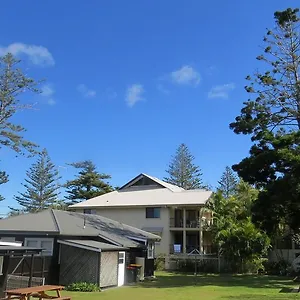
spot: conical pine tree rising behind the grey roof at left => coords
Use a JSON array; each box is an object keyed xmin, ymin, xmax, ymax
[{"xmin": 11, "ymin": 149, "xmax": 60, "ymax": 212}]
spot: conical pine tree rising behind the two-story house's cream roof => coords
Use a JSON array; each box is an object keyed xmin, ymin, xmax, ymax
[{"xmin": 163, "ymin": 144, "xmax": 206, "ymax": 190}]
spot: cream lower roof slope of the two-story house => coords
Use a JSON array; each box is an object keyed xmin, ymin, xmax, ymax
[{"xmin": 70, "ymin": 188, "xmax": 212, "ymax": 209}]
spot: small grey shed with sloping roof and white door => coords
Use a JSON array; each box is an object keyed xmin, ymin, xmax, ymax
[{"xmin": 58, "ymin": 240, "xmax": 128, "ymax": 288}]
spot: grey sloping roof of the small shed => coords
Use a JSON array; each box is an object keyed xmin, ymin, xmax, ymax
[{"xmin": 58, "ymin": 240, "xmax": 127, "ymax": 252}]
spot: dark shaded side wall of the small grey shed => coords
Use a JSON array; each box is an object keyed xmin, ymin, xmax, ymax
[{"xmin": 59, "ymin": 245, "xmax": 99, "ymax": 285}]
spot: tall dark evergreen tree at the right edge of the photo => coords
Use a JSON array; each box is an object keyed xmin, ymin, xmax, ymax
[{"xmin": 230, "ymin": 8, "xmax": 300, "ymax": 234}]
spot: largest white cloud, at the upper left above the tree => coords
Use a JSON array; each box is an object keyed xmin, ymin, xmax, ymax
[{"xmin": 0, "ymin": 43, "xmax": 55, "ymax": 66}]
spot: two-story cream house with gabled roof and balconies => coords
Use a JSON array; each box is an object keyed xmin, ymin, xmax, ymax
[{"xmin": 70, "ymin": 174, "xmax": 213, "ymax": 268}]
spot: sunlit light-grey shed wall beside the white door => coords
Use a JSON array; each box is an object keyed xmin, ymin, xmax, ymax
[{"xmin": 100, "ymin": 252, "xmax": 119, "ymax": 288}]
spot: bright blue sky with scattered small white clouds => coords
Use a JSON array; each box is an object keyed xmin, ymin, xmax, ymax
[{"xmin": 0, "ymin": 0, "xmax": 299, "ymax": 213}]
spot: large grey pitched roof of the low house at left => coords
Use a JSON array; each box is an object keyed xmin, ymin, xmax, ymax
[{"xmin": 0, "ymin": 209, "xmax": 160, "ymax": 248}]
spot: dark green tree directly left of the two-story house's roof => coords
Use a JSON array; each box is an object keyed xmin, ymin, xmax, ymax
[{"xmin": 64, "ymin": 160, "xmax": 113, "ymax": 204}]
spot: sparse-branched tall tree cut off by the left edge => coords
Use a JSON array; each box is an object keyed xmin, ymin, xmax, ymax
[{"xmin": 0, "ymin": 53, "xmax": 39, "ymax": 200}]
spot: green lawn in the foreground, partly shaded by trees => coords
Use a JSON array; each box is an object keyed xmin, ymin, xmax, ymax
[{"xmin": 64, "ymin": 273, "xmax": 300, "ymax": 300}]
